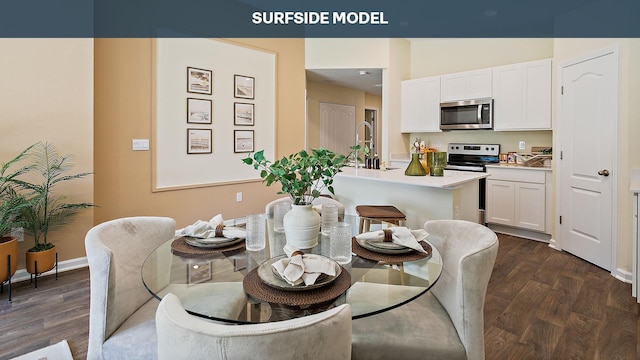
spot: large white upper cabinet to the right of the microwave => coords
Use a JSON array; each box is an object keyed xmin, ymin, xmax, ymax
[{"xmin": 493, "ymin": 59, "xmax": 551, "ymax": 131}]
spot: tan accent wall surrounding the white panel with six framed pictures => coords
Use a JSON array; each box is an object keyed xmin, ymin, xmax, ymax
[{"xmin": 95, "ymin": 39, "xmax": 305, "ymax": 227}]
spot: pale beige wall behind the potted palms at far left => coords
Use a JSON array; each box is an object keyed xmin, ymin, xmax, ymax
[{"xmin": 0, "ymin": 39, "xmax": 94, "ymax": 268}]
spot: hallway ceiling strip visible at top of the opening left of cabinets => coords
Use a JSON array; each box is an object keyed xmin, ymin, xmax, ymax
[{"xmin": 307, "ymin": 69, "xmax": 382, "ymax": 96}]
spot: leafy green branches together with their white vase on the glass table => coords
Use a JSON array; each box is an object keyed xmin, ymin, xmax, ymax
[{"xmin": 242, "ymin": 145, "xmax": 360, "ymax": 249}]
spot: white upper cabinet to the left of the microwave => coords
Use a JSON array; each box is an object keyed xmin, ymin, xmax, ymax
[{"xmin": 400, "ymin": 76, "xmax": 441, "ymax": 133}]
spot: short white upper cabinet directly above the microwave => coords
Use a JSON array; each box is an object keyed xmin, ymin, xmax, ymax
[{"xmin": 440, "ymin": 68, "xmax": 492, "ymax": 102}]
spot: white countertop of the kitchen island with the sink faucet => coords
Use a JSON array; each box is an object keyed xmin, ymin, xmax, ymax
[{"xmin": 336, "ymin": 167, "xmax": 490, "ymax": 189}]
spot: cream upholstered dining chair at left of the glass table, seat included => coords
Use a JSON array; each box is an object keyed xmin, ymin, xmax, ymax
[{"xmin": 85, "ymin": 217, "xmax": 176, "ymax": 360}]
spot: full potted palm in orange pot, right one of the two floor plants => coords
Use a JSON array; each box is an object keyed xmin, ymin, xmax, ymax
[{"xmin": 16, "ymin": 142, "xmax": 94, "ymax": 275}]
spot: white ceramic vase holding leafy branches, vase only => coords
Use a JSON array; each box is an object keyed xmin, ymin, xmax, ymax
[{"xmin": 282, "ymin": 204, "xmax": 320, "ymax": 249}]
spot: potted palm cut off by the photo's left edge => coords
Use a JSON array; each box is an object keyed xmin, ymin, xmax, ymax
[{"xmin": 0, "ymin": 147, "xmax": 30, "ymax": 301}]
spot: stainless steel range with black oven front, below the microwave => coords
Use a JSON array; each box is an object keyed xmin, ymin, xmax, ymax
[{"xmin": 445, "ymin": 143, "xmax": 500, "ymax": 224}]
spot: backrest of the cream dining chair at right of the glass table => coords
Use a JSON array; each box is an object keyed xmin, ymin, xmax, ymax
[{"xmin": 424, "ymin": 220, "xmax": 498, "ymax": 358}]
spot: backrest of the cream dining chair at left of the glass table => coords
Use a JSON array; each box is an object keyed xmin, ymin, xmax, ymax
[{"xmin": 85, "ymin": 217, "xmax": 175, "ymax": 358}]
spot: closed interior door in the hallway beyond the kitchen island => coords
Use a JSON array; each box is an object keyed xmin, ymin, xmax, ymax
[{"xmin": 319, "ymin": 103, "xmax": 356, "ymax": 154}]
